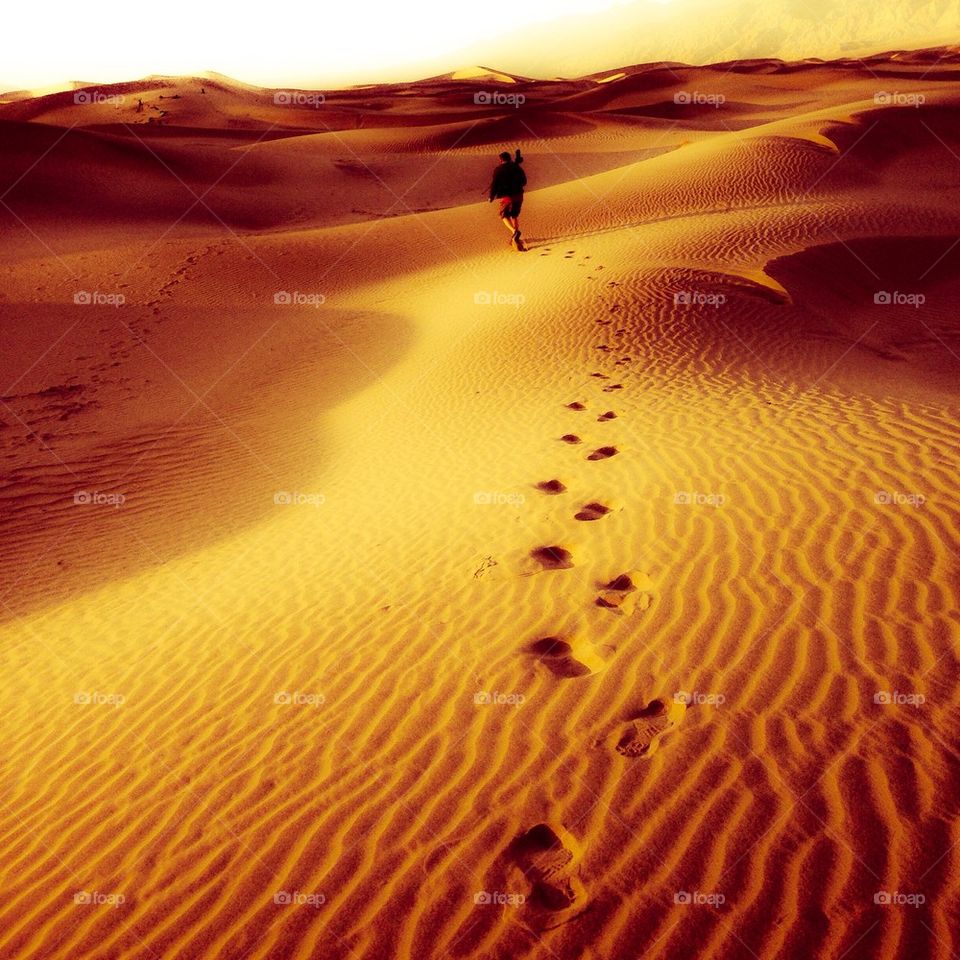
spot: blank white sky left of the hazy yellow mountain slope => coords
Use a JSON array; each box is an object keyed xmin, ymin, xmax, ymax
[{"xmin": 0, "ymin": 0, "xmax": 644, "ymax": 88}]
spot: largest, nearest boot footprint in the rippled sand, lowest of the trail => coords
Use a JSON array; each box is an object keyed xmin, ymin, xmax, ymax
[{"xmin": 509, "ymin": 823, "xmax": 586, "ymax": 911}]
